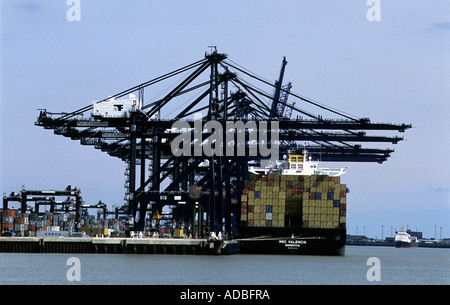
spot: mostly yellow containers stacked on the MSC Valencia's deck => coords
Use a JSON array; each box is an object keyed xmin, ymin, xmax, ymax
[{"xmin": 241, "ymin": 174, "xmax": 347, "ymax": 229}]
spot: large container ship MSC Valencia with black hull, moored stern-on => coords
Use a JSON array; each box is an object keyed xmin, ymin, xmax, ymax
[{"xmin": 238, "ymin": 151, "xmax": 348, "ymax": 255}]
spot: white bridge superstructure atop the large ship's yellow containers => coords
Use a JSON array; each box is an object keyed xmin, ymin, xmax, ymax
[{"xmin": 248, "ymin": 150, "xmax": 347, "ymax": 177}]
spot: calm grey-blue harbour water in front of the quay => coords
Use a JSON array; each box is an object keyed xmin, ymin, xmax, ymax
[{"xmin": 0, "ymin": 246, "xmax": 450, "ymax": 285}]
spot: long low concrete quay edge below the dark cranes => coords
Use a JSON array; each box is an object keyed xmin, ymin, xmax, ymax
[{"xmin": 0, "ymin": 237, "xmax": 240, "ymax": 255}]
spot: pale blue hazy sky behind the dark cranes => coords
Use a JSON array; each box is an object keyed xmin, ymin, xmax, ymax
[{"xmin": 0, "ymin": 0, "xmax": 450, "ymax": 238}]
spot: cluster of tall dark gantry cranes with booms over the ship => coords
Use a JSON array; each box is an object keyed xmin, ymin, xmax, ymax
[{"xmin": 35, "ymin": 50, "xmax": 411, "ymax": 235}]
